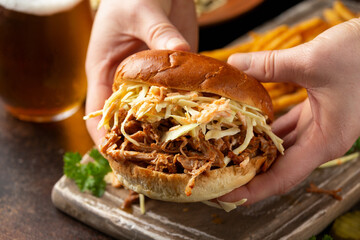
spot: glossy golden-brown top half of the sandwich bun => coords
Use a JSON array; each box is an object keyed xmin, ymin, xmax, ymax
[{"xmin": 113, "ymin": 50, "xmax": 274, "ymax": 121}]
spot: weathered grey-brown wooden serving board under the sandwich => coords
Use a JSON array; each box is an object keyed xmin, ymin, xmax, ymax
[{"xmin": 52, "ymin": 0, "xmax": 360, "ymax": 239}]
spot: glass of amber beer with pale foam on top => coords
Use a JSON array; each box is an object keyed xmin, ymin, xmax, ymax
[{"xmin": 0, "ymin": 0, "xmax": 93, "ymax": 122}]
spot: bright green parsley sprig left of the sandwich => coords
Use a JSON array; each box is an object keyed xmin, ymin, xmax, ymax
[{"xmin": 64, "ymin": 149, "xmax": 111, "ymax": 197}]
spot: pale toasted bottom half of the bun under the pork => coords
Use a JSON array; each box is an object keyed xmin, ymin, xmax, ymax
[{"xmin": 106, "ymin": 155, "xmax": 258, "ymax": 202}]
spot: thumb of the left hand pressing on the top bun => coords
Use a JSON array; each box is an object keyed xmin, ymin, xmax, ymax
[{"xmin": 138, "ymin": 6, "xmax": 190, "ymax": 51}]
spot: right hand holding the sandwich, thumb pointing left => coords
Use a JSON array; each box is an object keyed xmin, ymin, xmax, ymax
[{"xmin": 219, "ymin": 19, "xmax": 360, "ymax": 205}]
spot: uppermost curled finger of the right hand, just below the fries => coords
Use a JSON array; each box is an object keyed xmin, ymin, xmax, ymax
[{"xmin": 271, "ymin": 102, "xmax": 304, "ymax": 138}]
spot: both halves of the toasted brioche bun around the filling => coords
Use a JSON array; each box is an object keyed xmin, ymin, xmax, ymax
[{"xmin": 104, "ymin": 50, "xmax": 273, "ymax": 202}]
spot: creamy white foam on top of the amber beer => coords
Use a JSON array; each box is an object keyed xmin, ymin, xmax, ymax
[{"xmin": 0, "ymin": 0, "xmax": 83, "ymax": 16}]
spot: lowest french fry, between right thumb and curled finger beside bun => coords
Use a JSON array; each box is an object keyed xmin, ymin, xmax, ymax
[{"xmin": 273, "ymin": 88, "xmax": 307, "ymax": 112}]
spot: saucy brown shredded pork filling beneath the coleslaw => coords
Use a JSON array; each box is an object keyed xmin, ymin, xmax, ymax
[{"xmin": 101, "ymin": 114, "xmax": 277, "ymax": 196}]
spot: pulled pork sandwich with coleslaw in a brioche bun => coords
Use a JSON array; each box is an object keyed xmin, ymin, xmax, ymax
[{"xmin": 88, "ymin": 50, "xmax": 283, "ymax": 202}]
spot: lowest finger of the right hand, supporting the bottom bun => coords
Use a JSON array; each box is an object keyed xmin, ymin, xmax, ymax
[{"xmin": 219, "ymin": 124, "xmax": 329, "ymax": 205}]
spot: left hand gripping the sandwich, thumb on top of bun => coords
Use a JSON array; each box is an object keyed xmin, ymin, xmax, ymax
[{"xmin": 86, "ymin": 0, "xmax": 198, "ymax": 145}]
